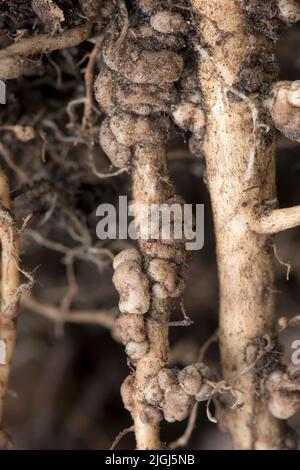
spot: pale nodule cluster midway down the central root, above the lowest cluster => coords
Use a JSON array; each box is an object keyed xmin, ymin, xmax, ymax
[{"xmin": 113, "ymin": 248, "xmax": 185, "ymax": 363}]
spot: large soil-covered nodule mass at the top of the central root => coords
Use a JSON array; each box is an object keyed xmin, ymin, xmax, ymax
[{"xmin": 95, "ymin": 0, "xmax": 204, "ymax": 168}]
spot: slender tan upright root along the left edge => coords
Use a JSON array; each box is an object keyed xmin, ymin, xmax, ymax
[{"xmin": 0, "ymin": 170, "xmax": 20, "ymax": 449}]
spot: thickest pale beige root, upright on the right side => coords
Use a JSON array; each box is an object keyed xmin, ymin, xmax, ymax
[{"xmin": 192, "ymin": 0, "xmax": 285, "ymax": 449}]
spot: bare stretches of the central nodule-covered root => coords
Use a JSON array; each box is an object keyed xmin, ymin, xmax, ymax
[{"xmin": 132, "ymin": 146, "xmax": 184, "ymax": 450}]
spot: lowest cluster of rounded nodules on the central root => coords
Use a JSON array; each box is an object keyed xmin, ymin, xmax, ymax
[{"xmin": 121, "ymin": 363, "xmax": 214, "ymax": 424}]
